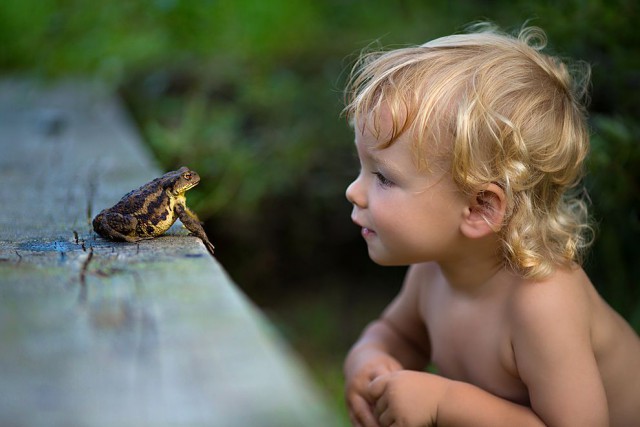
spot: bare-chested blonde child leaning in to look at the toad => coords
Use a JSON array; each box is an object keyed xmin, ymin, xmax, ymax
[{"xmin": 345, "ymin": 25, "xmax": 640, "ymax": 427}]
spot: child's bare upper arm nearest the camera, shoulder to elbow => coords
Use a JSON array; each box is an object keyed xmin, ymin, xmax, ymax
[{"xmin": 511, "ymin": 270, "xmax": 609, "ymax": 426}]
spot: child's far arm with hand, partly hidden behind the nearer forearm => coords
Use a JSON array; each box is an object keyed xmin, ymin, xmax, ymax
[{"xmin": 344, "ymin": 266, "xmax": 429, "ymax": 426}]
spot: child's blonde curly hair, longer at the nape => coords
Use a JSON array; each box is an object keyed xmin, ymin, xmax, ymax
[{"xmin": 345, "ymin": 23, "xmax": 592, "ymax": 279}]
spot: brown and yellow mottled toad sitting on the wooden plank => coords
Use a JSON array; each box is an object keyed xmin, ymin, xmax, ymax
[{"xmin": 93, "ymin": 166, "xmax": 214, "ymax": 254}]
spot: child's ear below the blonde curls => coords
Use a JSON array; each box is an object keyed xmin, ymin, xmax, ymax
[{"xmin": 461, "ymin": 184, "xmax": 507, "ymax": 239}]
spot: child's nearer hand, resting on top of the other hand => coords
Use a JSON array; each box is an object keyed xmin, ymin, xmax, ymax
[{"xmin": 368, "ymin": 371, "xmax": 449, "ymax": 427}]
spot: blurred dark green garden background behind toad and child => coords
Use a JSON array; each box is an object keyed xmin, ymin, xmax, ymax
[{"xmin": 0, "ymin": 0, "xmax": 640, "ymax": 422}]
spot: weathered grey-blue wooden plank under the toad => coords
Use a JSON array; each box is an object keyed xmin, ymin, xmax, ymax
[{"xmin": 0, "ymin": 80, "xmax": 339, "ymax": 427}]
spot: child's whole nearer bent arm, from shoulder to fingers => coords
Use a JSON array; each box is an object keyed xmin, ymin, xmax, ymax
[{"xmin": 368, "ymin": 270, "xmax": 609, "ymax": 427}]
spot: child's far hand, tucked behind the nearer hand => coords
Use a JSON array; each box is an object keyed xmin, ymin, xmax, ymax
[{"xmin": 346, "ymin": 353, "xmax": 402, "ymax": 427}]
